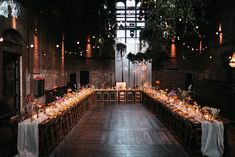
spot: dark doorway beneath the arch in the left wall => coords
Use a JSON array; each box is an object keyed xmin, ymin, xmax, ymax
[{"xmin": 3, "ymin": 52, "xmax": 20, "ymax": 114}]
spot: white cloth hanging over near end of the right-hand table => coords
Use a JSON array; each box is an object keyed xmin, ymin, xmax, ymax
[{"xmin": 201, "ymin": 121, "xmax": 224, "ymax": 157}]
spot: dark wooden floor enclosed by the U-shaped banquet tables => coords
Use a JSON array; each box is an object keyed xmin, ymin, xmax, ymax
[{"xmin": 51, "ymin": 104, "xmax": 188, "ymax": 157}]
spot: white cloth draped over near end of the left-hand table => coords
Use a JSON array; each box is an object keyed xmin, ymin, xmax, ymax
[{"xmin": 17, "ymin": 113, "xmax": 47, "ymax": 157}]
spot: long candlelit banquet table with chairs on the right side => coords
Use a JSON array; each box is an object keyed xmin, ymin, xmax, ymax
[{"xmin": 142, "ymin": 91, "xmax": 228, "ymax": 157}]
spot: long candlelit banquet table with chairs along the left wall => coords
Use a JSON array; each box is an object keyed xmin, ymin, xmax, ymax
[{"xmin": 17, "ymin": 91, "xmax": 94, "ymax": 157}]
